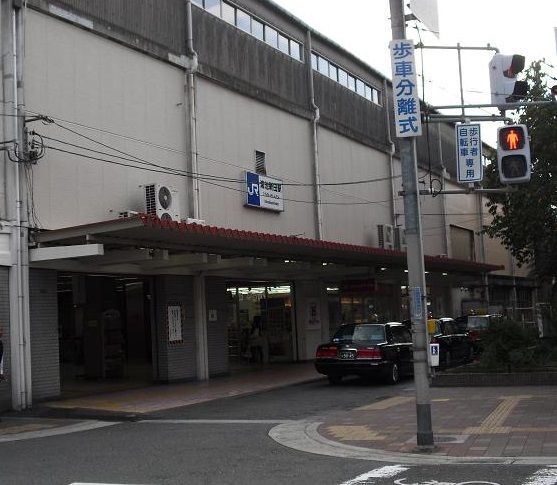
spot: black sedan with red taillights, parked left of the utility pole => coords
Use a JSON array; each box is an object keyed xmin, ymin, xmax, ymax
[{"xmin": 315, "ymin": 322, "xmax": 414, "ymax": 384}]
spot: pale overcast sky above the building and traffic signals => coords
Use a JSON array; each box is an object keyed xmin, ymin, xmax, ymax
[{"xmin": 273, "ymin": 0, "xmax": 557, "ymax": 146}]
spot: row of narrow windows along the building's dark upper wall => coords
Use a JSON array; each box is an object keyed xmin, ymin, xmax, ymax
[{"xmin": 192, "ymin": 0, "xmax": 380, "ymax": 104}]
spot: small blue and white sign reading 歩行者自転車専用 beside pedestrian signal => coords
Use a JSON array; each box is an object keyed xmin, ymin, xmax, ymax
[{"xmin": 455, "ymin": 123, "xmax": 483, "ymax": 183}]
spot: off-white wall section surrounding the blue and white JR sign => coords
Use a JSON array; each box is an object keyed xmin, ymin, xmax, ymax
[{"xmin": 193, "ymin": 79, "xmax": 315, "ymax": 238}]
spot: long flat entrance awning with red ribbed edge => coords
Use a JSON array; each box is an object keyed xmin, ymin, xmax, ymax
[{"xmin": 30, "ymin": 214, "xmax": 503, "ymax": 276}]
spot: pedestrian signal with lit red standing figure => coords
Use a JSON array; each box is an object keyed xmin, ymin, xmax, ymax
[{"xmin": 497, "ymin": 125, "xmax": 531, "ymax": 184}]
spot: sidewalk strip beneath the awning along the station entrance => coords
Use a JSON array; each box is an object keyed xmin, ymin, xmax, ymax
[{"xmin": 0, "ymin": 362, "xmax": 322, "ymax": 443}]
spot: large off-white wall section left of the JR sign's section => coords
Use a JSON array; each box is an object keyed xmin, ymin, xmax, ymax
[{"xmin": 25, "ymin": 11, "xmax": 187, "ymax": 229}]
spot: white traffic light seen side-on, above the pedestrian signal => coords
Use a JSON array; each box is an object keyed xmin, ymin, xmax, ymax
[{"xmin": 489, "ymin": 54, "xmax": 528, "ymax": 109}]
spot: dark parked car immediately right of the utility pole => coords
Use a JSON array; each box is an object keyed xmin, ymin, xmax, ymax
[{"xmin": 428, "ymin": 317, "xmax": 474, "ymax": 367}]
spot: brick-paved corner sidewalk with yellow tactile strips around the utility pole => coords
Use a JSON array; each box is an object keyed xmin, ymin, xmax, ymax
[{"xmin": 316, "ymin": 386, "xmax": 557, "ymax": 463}]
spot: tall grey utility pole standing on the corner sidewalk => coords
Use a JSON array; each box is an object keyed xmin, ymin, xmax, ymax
[{"xmin": 389, "ymin": 0, "xmax": 434, "ymax": 450}]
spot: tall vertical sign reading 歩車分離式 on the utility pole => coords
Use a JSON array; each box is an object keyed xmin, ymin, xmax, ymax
[{"xmin": 389, "ymin": 39, "xmax": 422, "ymax": 137}]
